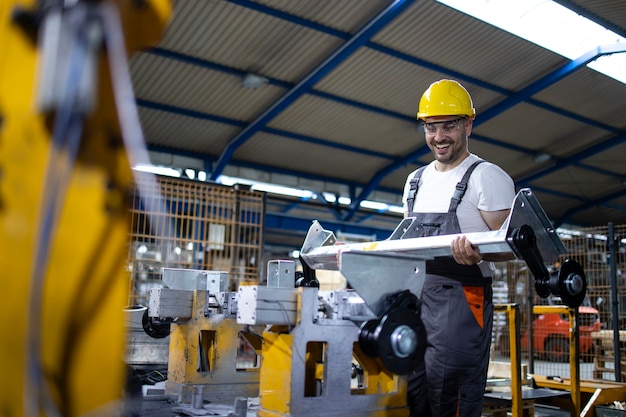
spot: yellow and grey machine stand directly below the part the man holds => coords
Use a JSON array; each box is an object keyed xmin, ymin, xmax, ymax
[{"xmin": 237, "ymin": 261, "xmax": 408, "ymax": 417}]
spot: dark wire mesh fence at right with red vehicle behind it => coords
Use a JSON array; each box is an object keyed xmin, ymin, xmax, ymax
[{"xmin": 492, "ymin": 224, "xmax": 626, "ymax": 382}]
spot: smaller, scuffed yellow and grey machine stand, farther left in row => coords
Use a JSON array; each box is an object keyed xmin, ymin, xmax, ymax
[{"xmin": 143, "ymin": 268, "xmax": 261, "ymax": 408}]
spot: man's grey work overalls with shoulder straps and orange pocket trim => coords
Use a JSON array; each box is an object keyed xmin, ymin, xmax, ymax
[{"xmin": 403, "ymin": 161, "xmax": 493, "ymax": 417}]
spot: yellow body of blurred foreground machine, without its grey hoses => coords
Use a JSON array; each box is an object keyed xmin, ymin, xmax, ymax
[{"xmin": 0, "ymin": 0, "xmax": 171, "ymax": 416}]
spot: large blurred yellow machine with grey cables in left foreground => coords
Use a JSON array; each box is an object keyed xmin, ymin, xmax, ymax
[{"xmin": 0, "ymin": 0, "xmax": 171, "ymax": 416}]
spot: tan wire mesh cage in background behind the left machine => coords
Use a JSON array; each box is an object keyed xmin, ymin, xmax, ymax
[{"xmin": 127, "ymin": 174, "xmax": 265, "ymax": 306}]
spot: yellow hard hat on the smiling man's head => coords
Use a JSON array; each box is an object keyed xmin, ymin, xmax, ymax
[{"xmin": 417, "ymin": 80, "xmax": 476, "ymax": 120}]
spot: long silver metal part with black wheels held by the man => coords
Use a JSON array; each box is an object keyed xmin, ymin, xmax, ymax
[{"xmin": 300, "ymin": 189, "xmax": 587, "ymax": 380}]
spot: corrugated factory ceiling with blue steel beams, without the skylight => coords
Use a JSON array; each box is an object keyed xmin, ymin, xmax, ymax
[{"xmin": 131, "ymin": 0, "xmax": 626, "ymax": 244}]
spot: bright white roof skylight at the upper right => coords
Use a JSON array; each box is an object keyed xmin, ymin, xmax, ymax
[{"xmin": 437, "ymin": 0, "xmax": 626, "ymax": 83}]
